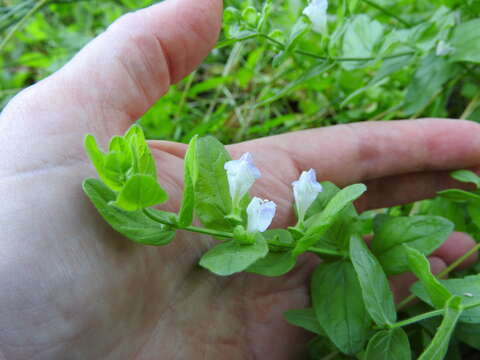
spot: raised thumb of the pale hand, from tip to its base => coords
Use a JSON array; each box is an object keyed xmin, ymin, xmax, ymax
[{"xmin": 0, "ymin": 0, "xmax": 222, "ymax": 140}]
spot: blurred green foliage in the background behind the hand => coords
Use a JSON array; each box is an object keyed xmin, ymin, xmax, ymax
[{"xmin": 0, "ymin": 0, "xmax": 480, "ymax": 143}]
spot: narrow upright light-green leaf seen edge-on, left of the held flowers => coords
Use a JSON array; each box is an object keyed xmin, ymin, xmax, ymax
[{"xmin": 178, "ymin": 136, "xmax": 198, "ymax": 227}]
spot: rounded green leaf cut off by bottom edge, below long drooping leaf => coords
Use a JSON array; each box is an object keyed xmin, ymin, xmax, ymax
[{"xmin": 365, "ymin": 328, "xmax": 412, "ymax": 360}]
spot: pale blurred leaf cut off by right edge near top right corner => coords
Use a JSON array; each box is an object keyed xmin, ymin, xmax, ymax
[{"xmin": 451, "ymin": 19, "xmax": 480, "ymax": 63}]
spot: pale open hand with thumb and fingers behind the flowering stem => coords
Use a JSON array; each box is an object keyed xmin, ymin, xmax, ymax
[{"xmin": 0, "ymin": 0, "xmax": 480, "ymax": 360}]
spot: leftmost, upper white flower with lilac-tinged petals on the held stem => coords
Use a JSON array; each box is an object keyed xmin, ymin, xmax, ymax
[{"xmin": 224, "ymin": 153, "xmax": 261, "ymax": 207}]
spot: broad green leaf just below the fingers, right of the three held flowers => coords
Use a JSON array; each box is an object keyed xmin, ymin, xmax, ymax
[{"xmin": 372, "ymin": 216, "xmax": 454, "ymax": 275}]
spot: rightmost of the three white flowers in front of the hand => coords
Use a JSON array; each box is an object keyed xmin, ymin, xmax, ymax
[{"xmin": 292, "ymin": 169, "xmax": 323, "ymax": 222}]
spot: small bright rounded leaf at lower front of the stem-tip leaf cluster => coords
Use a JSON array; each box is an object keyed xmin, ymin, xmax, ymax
[{"xmin": 113, "ymin": 175, "xmax": 168, "ymax": 211}]
